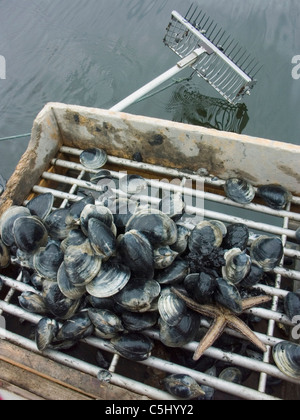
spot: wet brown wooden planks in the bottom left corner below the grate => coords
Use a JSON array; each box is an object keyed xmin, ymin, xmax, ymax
[{"xmin": 0, "ymin": 340, "xmax": 149, "ymax": 400}]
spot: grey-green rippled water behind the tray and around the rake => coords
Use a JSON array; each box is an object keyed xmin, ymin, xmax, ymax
[{"xmin": 0, "ymin": 0, "xmax": 300, "ymax": 178}]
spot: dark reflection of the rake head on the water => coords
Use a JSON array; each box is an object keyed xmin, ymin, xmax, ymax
[{"xmin": 167, "ymin": 85, "xmax": 249, "ymax": 134}]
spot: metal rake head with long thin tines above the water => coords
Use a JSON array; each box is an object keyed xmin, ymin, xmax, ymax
[{"xmin": 164, "ymin": 5, "xmax": 260, "ymax": 104}]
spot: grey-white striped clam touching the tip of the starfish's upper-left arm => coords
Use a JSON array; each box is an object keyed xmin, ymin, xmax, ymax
[{"xmin": 158, "ymin": 288, "xmax": 187, "ymax": 327}]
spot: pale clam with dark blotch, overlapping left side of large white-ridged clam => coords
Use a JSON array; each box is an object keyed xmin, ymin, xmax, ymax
[{"xmin": 64, "ymin": 239, "xmax": 102, "ymax": 286}]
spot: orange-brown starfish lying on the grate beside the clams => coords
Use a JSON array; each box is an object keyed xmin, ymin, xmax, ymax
[{"xmin": 172, "ymin": 288, "xmax": 272, "ymax": 361}]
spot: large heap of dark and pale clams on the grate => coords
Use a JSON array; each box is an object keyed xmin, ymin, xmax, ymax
[{"xmin": 0, "ymin": 153, "xmax": 298, "ymax": 398}]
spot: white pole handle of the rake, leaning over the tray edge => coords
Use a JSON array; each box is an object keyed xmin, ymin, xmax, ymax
[{"xmin": 110, "ymin": 47, "xmax": 207, "ymax": 111}]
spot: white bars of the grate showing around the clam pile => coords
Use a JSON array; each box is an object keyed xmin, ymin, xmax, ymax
[{"xmin": 0, "ymin": 147, "xmax": 300, "ymax": 400}]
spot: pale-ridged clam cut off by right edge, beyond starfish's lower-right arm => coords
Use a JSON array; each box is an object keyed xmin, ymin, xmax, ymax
[{"xmin": 273, "ymin": 341, "xmax": 300, "ymax": 380}]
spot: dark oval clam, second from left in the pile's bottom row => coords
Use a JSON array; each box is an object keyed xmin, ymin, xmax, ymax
[{"xmin": 56, "ymin": 311, "xmax": 94, "ymax": 341}]
